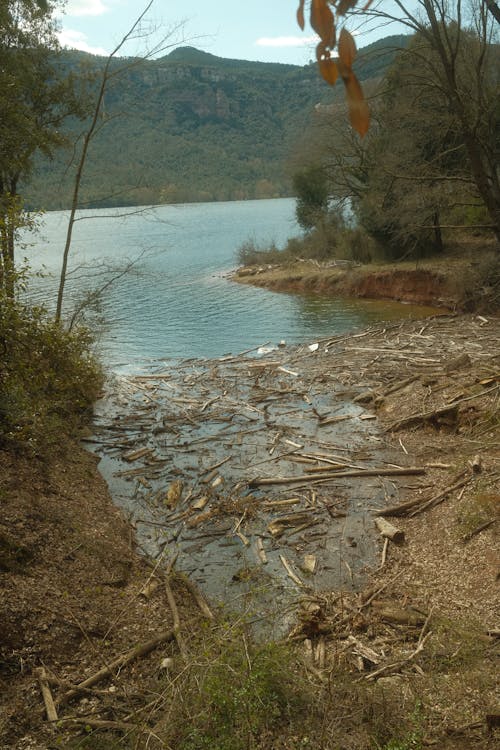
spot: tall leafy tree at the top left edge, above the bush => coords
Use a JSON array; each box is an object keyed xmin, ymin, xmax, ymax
[{"xmin": 0, "ymin": 0, "xmax": 81, "ymax": 296}]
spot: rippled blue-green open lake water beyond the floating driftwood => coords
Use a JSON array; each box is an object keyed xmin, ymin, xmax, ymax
[{"xmin": 25, "ymin": 199, "xmax": 434, "ymax": 371}]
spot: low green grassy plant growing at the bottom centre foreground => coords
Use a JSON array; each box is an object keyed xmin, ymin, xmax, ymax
[{"xmin": 168, "ymin": 628, "xmax": 312, "ymax": 750}]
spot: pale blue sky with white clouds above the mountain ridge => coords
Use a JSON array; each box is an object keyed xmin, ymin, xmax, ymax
[{"xmin": 55, "ymin": 0, "xmax": 406, "ymax": 65}]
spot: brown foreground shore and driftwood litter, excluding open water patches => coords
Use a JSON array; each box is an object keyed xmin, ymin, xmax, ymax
[{"xmin": 0, "ymin": 315, "xmax": 500, "ymax": 750}]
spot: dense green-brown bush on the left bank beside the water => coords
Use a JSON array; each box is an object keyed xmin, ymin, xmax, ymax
[{"xmin": 0, "ymin": 296, "xmax": 103, "ymax": 451}]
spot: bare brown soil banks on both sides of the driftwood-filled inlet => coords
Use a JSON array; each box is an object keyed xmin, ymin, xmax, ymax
[{"xmin": 0, "ymin": 315, "xmax": 500, "ymax": 750}]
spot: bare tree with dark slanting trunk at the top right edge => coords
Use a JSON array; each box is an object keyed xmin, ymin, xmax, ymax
[{"xmin": 369, "ymin": 0, "xmax": 500, "ymax": 242}]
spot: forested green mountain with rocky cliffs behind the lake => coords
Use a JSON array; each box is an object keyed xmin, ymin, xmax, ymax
[{"xmin": 24, "ymin": 37, "xmax": 409, "ymax": 209}]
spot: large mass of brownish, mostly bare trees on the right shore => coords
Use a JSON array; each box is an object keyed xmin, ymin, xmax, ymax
[{"xmin": 292, "ymin": 0, "xmax": 500, "ymax": 254}]
